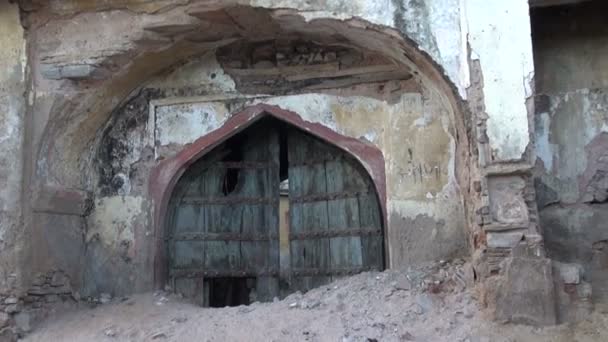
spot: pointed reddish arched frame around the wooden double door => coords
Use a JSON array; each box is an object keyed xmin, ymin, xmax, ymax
[{"xmin": 148, "ymin": 104, "xmax": 389, "ymax": 288}]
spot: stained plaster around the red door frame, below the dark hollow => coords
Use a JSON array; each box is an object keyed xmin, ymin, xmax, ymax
[{"xmin": 84, "ymin": 52, "xmax": 468, "ymax": 294}]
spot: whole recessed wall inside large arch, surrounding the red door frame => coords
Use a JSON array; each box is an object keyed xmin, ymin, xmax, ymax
[{"xmin": 85, "ymin": 45, "xmax": 467, "ymax": 293}]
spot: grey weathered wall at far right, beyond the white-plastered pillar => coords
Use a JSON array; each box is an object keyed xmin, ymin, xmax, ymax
[{"xmin": 533, "ymin": 2, "xmax": 608, "ymax": 320}]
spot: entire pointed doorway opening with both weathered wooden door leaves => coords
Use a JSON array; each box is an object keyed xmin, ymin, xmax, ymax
[{"xmin": 165, "ymin": 117, "xmax": 384, "ymax": 306}]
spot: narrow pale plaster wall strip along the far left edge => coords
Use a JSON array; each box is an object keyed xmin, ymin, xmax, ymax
[{"xmin": 0, "ymin": 2, "xmax": 25, "ymax": 292}]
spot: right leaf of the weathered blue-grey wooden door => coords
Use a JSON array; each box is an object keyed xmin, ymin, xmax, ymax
[{"xmin": 288, "ymin": 129, "xmax": 384, "ymax": 291}]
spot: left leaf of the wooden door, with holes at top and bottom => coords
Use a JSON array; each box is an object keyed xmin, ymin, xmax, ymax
[{"xmin": 167, "ymin": 129, "xmax": 279, "ymax": 305}]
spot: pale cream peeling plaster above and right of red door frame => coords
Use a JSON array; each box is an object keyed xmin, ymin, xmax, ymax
[{"xmin": 144, "ymin": 82, "xmax": 466, "ymax": 265}]
